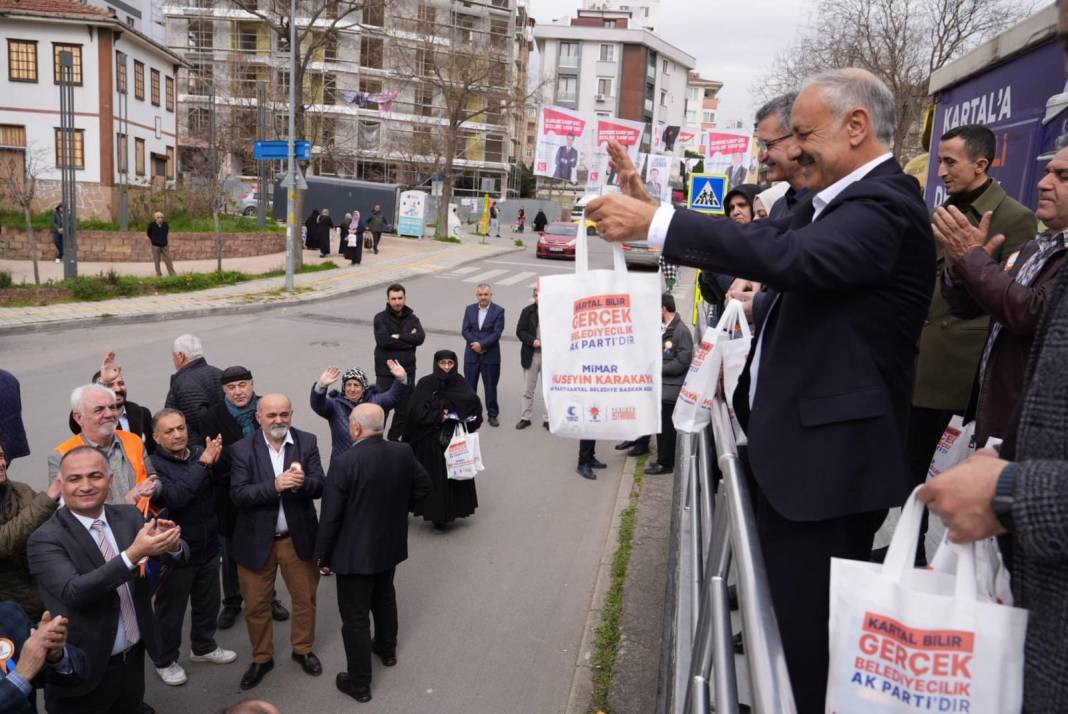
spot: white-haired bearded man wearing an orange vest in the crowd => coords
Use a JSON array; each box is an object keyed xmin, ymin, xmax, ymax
[{"xmin": 48, "ymin": 384, "xmax": 156, "ymax": 504}]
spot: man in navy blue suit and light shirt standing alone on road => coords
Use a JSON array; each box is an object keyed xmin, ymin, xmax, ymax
[{"xmin": 460, "ymin": 283, "xmax": 504, "ymax": 427}]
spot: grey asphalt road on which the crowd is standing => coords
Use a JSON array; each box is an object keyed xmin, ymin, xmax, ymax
[{"xmin": 0, "ymin": 234, "xmax": 649, "ymax": 714}]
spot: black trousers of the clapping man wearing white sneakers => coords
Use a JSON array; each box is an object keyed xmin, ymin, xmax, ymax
[{"xmin": 154, "ymin": 557, "xmax": 220, "ymax": 667}]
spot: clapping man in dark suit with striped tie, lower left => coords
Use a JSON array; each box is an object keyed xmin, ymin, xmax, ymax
[{"xmin": 27, "ymin": 446, "xmax": 187, "ymax": 714}]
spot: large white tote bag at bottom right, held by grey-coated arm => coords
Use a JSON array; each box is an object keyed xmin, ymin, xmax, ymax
[{"xmin": 826, "ymin": 492, "xmax": 1027, "ymax": 714}]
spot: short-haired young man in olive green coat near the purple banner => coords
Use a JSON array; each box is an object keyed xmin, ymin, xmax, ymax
[{"xmin": 907, "ymin": 124, "xmax": 1036, "ymax": 529}]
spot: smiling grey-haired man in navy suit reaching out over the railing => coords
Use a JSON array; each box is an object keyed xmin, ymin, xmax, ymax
[{"xmin": 588, "ymin": 69, "xmax": 935, "ymax": 712}]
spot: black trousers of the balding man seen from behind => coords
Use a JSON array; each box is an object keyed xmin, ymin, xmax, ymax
[{"xmin": 337, "ymin": 568, "xmax": 397, "ymax": 688}]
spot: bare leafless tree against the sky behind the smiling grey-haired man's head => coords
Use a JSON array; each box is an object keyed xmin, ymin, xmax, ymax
[{"xmin": 752, "ymin": 0, "xmax": 1033, "ymax": 157}]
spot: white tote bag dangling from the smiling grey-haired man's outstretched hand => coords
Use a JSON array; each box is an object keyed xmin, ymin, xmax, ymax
[{"xmin": 538, "ymin": 216, "xmax": 663, "ymax": 440}]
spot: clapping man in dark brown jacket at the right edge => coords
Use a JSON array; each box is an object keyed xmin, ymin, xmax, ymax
[{"xmin": 932, "ymin": 143, "xmax": 1068, "ymax": 445}]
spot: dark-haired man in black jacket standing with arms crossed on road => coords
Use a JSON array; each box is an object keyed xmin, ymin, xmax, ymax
[{"xmin": 374, "ymin": 283, "xmax": 426, "ymax": 441}]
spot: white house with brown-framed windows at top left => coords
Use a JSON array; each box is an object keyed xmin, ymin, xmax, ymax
[{"xmin": 0, "ymin": 0, "xmax": 182, "ymax": 220}]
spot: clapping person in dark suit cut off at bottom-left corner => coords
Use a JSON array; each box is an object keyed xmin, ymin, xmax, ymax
[{"xmin": 0, "ymin": 600, "xmax": 85, "ymax": 714}]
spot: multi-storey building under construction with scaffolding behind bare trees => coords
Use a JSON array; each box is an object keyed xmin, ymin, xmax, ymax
[{"xmin": 163, "ymin": 0, "xmax": 532, "ymax": 194}]
